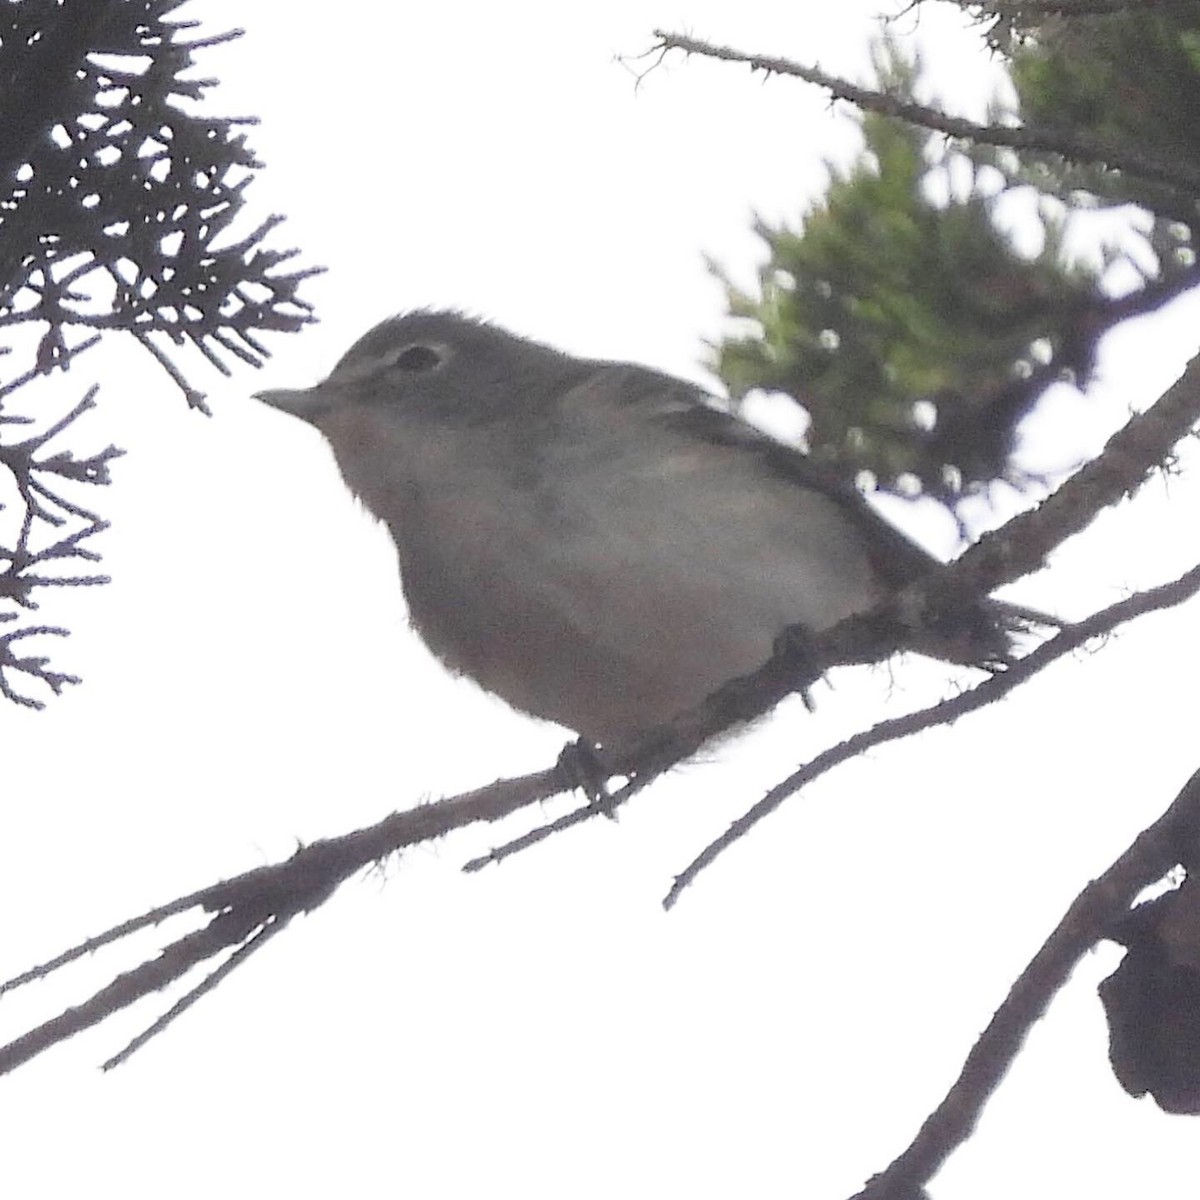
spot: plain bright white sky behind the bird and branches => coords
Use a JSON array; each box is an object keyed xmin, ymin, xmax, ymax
[{"xmin": 0, "ymin": 0, "xmax": 1200, "ymax": 1200}]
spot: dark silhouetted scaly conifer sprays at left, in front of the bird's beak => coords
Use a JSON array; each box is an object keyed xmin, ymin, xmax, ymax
[{"xmin": 0, "ymin": 0, "xmax": 313, "ymax": 708}]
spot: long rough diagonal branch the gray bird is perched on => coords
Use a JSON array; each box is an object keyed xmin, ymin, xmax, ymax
[{"xmin": 9, "ymin": 331, "xmax": 1200, "ymax": 1070}]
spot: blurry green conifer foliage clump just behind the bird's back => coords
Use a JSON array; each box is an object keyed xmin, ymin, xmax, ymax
[{"xmin": 715, "ymin": 46, "xmax": 1097, "ymax": 502}]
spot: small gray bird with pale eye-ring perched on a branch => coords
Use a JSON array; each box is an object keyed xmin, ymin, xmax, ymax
[{"xmin": 257, "ymin": 311, "xmax": 1018, "ymax": 743}]
